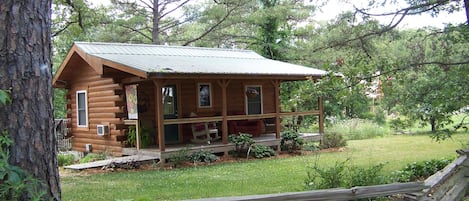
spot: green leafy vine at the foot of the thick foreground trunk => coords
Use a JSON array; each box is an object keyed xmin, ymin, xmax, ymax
[{"xmin": 0, "ymin": 131, "xmax": 45, "ymax": 201}]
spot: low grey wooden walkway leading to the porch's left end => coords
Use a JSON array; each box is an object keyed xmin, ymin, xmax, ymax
[{"xmin": 64, "ymin": 155, "xmax": 160, "ymax": 170}]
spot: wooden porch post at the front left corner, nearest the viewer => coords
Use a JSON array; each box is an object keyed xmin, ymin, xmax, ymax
[{"xmin": 153, "ymin": 80, "xmax": 165, "ymax": 152}]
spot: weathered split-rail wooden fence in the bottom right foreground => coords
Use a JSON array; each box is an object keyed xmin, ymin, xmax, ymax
[{"xmin": 190, "ymin": 150, "xmax": 469, "ymax": 201}]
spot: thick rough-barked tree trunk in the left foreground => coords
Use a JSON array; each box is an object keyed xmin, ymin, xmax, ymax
[{"xmin": 0, "ymin": 0, "xmax": 61, "ymax": 200}]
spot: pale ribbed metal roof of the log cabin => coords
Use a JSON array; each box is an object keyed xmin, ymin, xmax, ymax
[{"xmin": 75, "ymin": 42, "xmax": 326, "ymax": 76}]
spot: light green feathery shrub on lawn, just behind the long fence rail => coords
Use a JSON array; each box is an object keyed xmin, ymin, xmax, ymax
[{"xmin": 305, "ymin": 159, "xmax": 388, "ymax": 190}]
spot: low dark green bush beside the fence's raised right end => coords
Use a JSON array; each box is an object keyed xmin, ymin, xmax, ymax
[{"xmin": 394, "ymin": 158, "xmax": 452, "ymax": 182}]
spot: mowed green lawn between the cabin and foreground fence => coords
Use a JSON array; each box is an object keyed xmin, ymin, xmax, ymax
[{"xmin": 61, "ymin": 134, "xmax": 469, "ymax": 201}]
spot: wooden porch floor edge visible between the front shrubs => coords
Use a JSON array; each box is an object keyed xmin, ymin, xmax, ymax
[{"xmin": 122, "ymin": 133, "xmax": 322, "ymax": 160}]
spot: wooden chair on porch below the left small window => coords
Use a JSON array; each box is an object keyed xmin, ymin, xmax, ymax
[{"xmin": 191, "ymin": 113, "xmax": 221, "ymax": 143}]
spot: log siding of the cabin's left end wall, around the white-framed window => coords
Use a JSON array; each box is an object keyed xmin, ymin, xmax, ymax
[{"xmin": 67, "ymin": 62, "xmax": 125, "ymax": 155}]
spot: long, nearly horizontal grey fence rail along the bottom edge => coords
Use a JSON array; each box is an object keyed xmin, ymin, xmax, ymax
[{"xmin": 190, "ymin": 182, "xmax": 425, "ymax": 201}]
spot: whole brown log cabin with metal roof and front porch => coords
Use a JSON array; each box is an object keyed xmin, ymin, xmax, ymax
[{"xmin": 53, "ymin": 42, "xmax": 326, "ymax": 156}]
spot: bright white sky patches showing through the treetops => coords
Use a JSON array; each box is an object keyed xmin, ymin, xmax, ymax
[{"xmin": 90, "ymin": 0, "xmax": 466, "ymax": 29}]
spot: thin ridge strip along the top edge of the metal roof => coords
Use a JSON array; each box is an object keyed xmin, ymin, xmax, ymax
[{"xmin": 74, "ymin": 41, "xmax": 255, "ymax": 53}]
